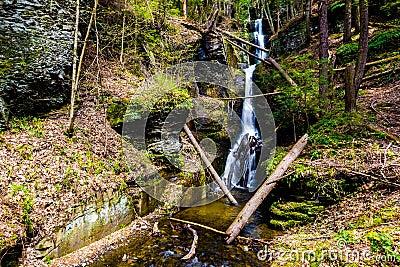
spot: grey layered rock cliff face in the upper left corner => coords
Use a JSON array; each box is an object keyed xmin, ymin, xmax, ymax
[{"xmin": 0, "ymin": 0, "xmax": 75, "ymax": 127}]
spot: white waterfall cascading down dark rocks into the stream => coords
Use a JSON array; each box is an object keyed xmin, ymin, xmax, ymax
[{"xmin": 223, "ymin": 19, "xmax": 267, "ymax": 191}]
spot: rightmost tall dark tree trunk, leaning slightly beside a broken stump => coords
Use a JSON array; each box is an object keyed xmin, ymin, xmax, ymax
[{"xmin": 354, "ymin": 0, "xmax": 368, "ymax": 97}]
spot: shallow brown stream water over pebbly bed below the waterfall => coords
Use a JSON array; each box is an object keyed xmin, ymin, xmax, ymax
[{"xmin": 90, "ymin": 190, "xmax": 282, "ymax": 267}]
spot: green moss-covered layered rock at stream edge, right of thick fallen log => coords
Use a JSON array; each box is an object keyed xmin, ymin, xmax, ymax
[{"xmin": 269, "ymin": 201, "xmax": 324, "ymax": 229}]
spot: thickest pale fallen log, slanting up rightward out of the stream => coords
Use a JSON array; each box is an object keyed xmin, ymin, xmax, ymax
[{"xmin": 226, "ymin": 134, "xmax": 308, "ymax": 244}]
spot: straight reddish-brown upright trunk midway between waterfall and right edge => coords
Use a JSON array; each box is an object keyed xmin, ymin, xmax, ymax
[{"xmin": 319, "ymin": 0, "xmax": 329, "ymax": 102}]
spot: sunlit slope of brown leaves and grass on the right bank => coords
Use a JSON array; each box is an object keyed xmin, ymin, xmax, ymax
[{"xmin": 267, "ymin": 67, "xmax": 400, "ymax": 266}]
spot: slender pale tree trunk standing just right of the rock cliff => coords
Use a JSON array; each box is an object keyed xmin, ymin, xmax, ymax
[{"xmin": 67, "ymin": 0, "xmax": 80, "ymax": 134}]
